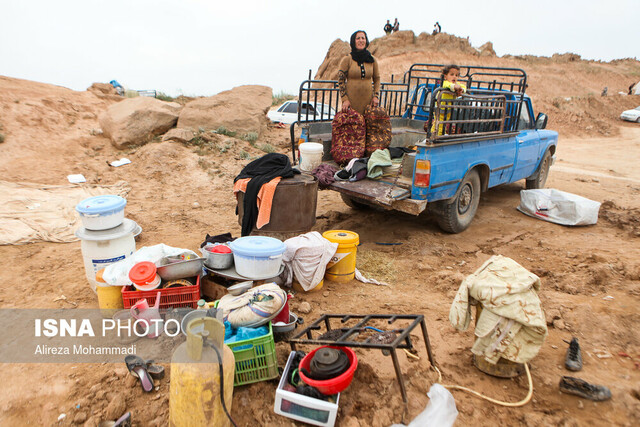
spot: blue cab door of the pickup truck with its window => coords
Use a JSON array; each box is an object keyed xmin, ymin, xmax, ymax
[{"xmin": 511, "ymin": 98, "xmax": 540, "ymax": 182}]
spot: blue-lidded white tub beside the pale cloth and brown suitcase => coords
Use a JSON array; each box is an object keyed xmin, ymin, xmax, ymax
[{"xmin": 229, "ymin": 236, "xmax": 287, "ymax": 280}]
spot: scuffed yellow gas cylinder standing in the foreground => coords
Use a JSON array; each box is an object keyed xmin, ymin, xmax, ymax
[{"xmin": 169, "ymin": 317, "xmax": 235, "ymax": 427}]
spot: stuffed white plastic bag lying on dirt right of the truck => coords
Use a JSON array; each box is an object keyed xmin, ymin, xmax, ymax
[{"xmin": 518, "ymin": 188, "xmax": 600, "ymax": 225}]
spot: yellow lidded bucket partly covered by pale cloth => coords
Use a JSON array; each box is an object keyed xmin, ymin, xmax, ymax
[{"xmin": 322, "ymin": 230, "xmax": 360, "ymax": 282}]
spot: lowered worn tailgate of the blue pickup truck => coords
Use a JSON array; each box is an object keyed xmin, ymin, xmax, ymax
[{"xmin": 329, "ymin": 179, "xmax": 427, "ymax": 215}]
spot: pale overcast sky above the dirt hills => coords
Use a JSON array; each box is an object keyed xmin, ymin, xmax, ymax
[{"xmin": 0, "ymin": 0, "xmax": 640, "ymax": 96}]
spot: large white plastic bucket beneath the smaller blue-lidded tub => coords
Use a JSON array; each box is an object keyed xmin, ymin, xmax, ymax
[{"xmin": 76, "ymin": 218, "xmax": 138, "ymax": 292}]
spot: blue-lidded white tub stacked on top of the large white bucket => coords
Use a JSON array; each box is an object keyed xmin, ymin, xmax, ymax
[{"xmin": 76, "ymin": 195, "xmax": 127, "ymax": 230}]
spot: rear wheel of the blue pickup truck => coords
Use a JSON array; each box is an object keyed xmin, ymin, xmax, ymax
[{"xmin": 437, "ymin": 170, "xmax": 481, "ymax": 233}]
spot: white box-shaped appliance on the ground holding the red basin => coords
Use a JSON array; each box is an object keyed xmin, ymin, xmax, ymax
[{"xmin": 273, "ymin": 351, "xmax": 340, "ymax": 427}]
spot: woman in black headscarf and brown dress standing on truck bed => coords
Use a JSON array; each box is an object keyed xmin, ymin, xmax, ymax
[{"xmin": 338, "ymin": 30, "xmax": 380, "ymax": 114}]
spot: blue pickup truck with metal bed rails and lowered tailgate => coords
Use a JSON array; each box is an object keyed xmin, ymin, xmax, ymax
[{"xmin": 291, "ymin": 64, "xmax": 558, "ymax": 233}]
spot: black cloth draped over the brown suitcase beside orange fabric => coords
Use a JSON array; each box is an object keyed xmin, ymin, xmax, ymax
[{"xmin": 233, "ymin": 153, "xmax": 300, "ymax": 236}]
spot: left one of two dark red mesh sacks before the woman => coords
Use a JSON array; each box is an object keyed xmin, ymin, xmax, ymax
[{"xmin": 331, "ymin": 109, "xmax": 366, "ymax": 165}]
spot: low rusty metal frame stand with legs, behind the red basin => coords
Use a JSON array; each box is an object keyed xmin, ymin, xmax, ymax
[{"xmin": 287, "ymin": 314, "xmax": 436, "ymax": 403}]
